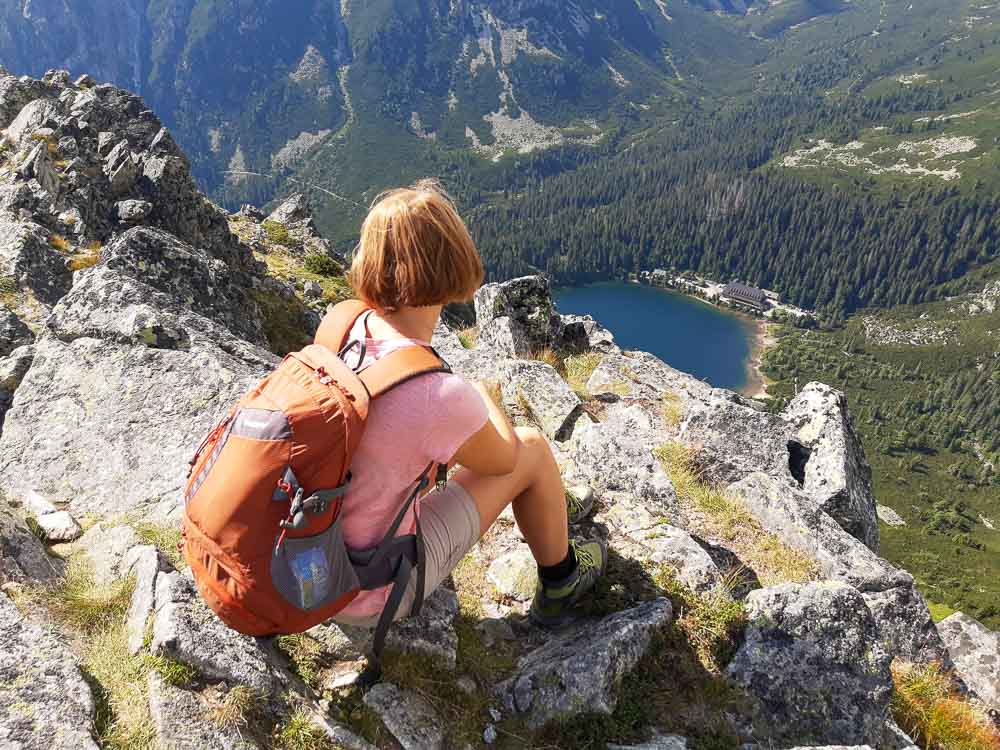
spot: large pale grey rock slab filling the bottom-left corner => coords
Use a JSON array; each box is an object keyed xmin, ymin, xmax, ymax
[{"xmin": 0, "ymin": 593, "xmax": 97, "ymax": 750}]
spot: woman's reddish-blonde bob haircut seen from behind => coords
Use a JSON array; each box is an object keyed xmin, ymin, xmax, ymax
[{"xmin": 348, "ymin": 180, "xmax": 483, "ymax": 312}]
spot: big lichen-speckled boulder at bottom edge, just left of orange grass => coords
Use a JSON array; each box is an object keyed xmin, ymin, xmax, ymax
[{"xmin": 727, "ymin": 582, "xmax": 892, "ymax": 745}]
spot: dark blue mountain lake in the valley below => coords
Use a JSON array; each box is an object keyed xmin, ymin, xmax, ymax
[{"xmin": 554, "ymin": 281, "xmax": 754, "ymax": 390}]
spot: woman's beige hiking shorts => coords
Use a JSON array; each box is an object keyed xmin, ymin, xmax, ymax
[{"xmin": 333, "ymin": 481, "xmax": 480, "ymax": 628}]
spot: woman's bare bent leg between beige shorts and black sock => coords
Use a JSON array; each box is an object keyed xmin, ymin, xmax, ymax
[{"xmin": 455, "ymin": 427, "xmax": 569, "ymax": 566}]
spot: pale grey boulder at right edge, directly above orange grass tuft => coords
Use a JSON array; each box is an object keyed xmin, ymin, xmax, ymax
[{"xmin": 937, "ymin": 612, "xmax": 1000, "ymax": 711}]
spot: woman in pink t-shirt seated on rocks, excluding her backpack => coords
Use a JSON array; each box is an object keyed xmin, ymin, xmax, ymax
[{"xmin": 334, "ymin": 181, "xmax": 607, "ymax": 627}]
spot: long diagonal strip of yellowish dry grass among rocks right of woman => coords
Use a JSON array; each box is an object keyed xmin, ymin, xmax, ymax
[{"xmin": 654, "ymin": 443, "xmax": 819, "ymax": 586}]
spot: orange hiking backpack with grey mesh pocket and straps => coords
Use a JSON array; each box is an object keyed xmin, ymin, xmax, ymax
[{"xmin": 183, "ymin": 301, "xmax": 450, "ymax": 657}]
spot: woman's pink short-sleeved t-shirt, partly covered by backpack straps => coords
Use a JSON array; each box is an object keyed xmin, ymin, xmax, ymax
[{"xmin": 342, "ymin": 328, "xmax": 489, "ymax": 618}]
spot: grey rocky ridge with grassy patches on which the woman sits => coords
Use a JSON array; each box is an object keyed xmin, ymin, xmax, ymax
[{"xmin": 0, "ymin": 72, "xmax": 997, "ymax": 750}]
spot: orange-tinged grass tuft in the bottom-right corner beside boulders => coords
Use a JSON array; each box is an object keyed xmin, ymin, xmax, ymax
[{"xmin": 892, "ymin": 664, "xmax": 1000, "ymax": 750}]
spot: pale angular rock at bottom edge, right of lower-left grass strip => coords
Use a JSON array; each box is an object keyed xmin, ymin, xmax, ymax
[{"xmin": 146, "ymin": 671, "xmax": 259, "ymax": 750}]
